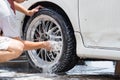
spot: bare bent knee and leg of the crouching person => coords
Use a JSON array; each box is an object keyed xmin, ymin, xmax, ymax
[{"xmin": 0, "ymin": 39, "xmax": 24, "ymax": 63}]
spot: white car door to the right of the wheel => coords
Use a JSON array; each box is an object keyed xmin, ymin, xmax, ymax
[{"xmin": 79, "ymin": 0, "xmax": 120, "ymax": 50}]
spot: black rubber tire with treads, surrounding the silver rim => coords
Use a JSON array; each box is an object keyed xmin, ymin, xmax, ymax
[{"xmin": 24, "ymin": 8, "xmax": 78, "ymax": 73}]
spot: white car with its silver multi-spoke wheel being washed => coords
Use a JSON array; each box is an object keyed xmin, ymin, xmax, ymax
[{"xmin": 17, "ymin": 0, "xmax": 120, "ymax": 73}]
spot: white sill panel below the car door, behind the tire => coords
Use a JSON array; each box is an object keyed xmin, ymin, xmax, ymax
[{"xmin": 75, "ymin": 33, "xmax": 120, "ymax": 60}]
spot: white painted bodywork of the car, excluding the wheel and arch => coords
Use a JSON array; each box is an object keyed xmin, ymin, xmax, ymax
[{"xmin": 17, "ymin": 0, "xmax": 120, "ymax": 60}]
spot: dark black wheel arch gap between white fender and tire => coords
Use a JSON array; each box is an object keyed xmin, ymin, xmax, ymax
[{"xmin": 22, "ymin": 1, "xmax": 76, "ymax": 44}]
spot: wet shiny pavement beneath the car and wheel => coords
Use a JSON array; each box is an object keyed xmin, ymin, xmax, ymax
[{"xmin": 0, "ymin": 61, "xmax": 120, "ymax": 80}]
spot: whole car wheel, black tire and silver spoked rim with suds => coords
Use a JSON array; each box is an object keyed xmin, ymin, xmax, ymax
[{"xmin": 24, "ymin": 8, "xmax": 78, "ymax": 73}]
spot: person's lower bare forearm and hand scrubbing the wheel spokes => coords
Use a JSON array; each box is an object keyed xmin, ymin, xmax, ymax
[{"xmin": 14, "ymin": 37, "xmax": 51, "ymax": 50}]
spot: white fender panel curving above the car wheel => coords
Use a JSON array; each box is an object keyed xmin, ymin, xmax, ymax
[{"xmin": 18, "ymin": 0, "xmax": 79, "ymax": 31}]
